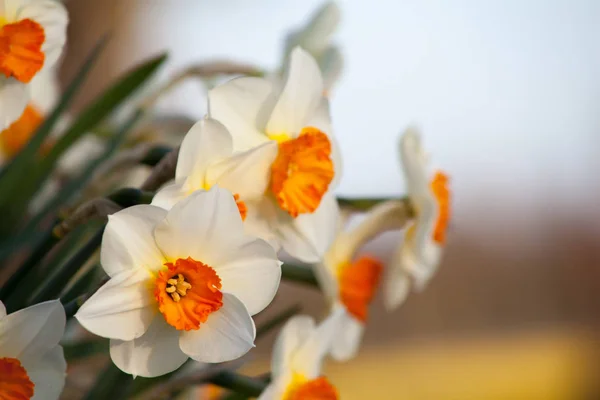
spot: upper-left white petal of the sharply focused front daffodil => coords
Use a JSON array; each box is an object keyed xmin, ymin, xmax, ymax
[{"xmin": 100, "ymin": 204, "xmax": 167, "ymax": 276}]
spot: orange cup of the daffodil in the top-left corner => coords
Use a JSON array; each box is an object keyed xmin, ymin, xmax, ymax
[{"xmin": 0, "ymin": 19, "xmax": 46, "ymax": 83}]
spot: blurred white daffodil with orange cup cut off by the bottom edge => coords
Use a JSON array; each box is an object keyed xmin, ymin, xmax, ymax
[{"xmin": 258, "ymin": 314, "xmax": 339, "ymax": 400}]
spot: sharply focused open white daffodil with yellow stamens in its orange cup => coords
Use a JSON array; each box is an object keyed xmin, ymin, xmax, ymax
[{"xmin": 76, "ymin": 187, "xmax": 281, "ymax": 377}]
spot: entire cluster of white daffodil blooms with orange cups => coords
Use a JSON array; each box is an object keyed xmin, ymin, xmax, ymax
[{"xmin": 0, "ymin": 0, "xmax": 450, "ymax": 400}]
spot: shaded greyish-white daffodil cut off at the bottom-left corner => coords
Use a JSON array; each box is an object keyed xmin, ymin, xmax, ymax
[{"xmin": 0, "ymin": 300, "xmax": 67, "ymax": 400}]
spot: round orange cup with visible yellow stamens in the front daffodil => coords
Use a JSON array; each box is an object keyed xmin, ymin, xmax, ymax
[{"xmin": 154, "ymin": 257, "xmax": 223, "ymax": 331}]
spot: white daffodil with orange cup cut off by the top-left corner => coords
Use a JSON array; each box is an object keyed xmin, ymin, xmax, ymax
[{"xmin": 0, "ymin": 0, "xmax": 68, "ymax": 129}]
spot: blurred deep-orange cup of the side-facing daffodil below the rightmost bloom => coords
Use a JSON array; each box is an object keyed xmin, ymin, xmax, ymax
[{"xmin": 339, "ymin": 256, "xmax": 383, "ymax": 322}]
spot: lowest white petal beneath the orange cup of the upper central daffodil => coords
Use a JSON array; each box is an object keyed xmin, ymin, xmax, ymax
[{"xmin": 278, "ymin": 192, "xmax": 339, "ymax": 263}]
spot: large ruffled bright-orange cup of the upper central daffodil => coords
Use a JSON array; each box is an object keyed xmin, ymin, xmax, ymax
[{"xmin": 271, "ymin": 127, "xmax": 334, "ymax": 218}]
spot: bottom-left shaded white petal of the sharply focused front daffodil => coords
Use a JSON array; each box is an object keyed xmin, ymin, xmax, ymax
[{"xmin": 110, "ymin": 315, "xmax": 188, "ymax": 378}]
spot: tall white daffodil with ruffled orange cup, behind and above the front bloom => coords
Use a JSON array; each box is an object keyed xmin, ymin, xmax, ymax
[{"xmin": 209, "ymin": 48, "xmax": 342, "ymax": 262}]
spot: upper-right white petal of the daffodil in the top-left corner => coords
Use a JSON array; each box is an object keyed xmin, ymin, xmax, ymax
[{"xmin": 17, "ymin": 0, "xmax": 69, "ymax": 68}]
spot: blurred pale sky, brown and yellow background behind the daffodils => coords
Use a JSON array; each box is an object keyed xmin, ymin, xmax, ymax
[{"xmin": 61, "ymin": 0, "xmax": 600, "ymax": 400}]
